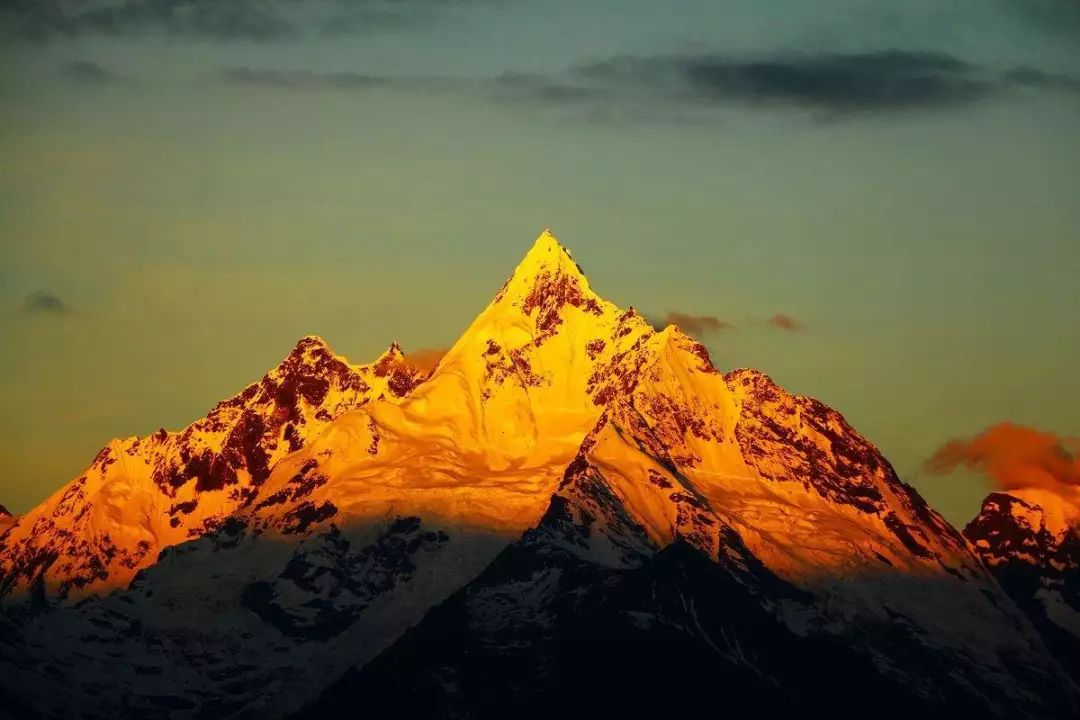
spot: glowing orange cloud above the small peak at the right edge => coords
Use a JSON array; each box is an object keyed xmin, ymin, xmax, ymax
[{"xmin": 924, "ymin": 422, "xmax": 1080, "ymax": 495}]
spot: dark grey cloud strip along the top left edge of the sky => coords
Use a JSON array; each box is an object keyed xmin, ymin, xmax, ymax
[{"xmin": 0, "ymin": 0, "xmax": 438, "ymax": 42}]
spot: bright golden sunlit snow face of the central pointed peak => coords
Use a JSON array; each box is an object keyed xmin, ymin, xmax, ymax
[{"xmin": 245, "ymin": 233, "xmax": 652, "ymax": 539}]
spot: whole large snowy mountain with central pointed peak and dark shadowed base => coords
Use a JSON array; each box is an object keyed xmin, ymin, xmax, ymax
[{"xmin": 0, "ymin": 232, "xmax": 1075, "ymax": 718}]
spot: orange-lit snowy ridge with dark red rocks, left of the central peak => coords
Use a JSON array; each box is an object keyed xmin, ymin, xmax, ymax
[{"xmin": 0, "ymin": 336, "xmax": 422, "ymax": 603}]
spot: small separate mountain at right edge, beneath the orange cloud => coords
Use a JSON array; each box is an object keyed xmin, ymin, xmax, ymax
[{"xmin": 963, "ymin": 489, "xmax": 1080, "ymax": 668}]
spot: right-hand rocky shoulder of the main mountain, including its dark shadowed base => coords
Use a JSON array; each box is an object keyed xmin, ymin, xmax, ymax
[{"xmin": 303, "ymin": 321, "xmax": 1075, "ymax": 718}]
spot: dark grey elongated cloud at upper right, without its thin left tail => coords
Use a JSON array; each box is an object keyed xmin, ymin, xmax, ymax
[{"xmin": 499, "ymin": 49, "xmax": 1080, "ymax": 122}]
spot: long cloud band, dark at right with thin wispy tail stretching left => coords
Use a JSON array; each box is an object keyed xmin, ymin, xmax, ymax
[{"xmin": 214, "ymin": 50, "xmax": 1080, "ymax": 124}]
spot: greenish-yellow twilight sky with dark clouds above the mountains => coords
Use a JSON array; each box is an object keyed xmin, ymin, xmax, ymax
[{"xmin": 0, "ymin": 0, "xmax": 1080, "ymax": 525}]
